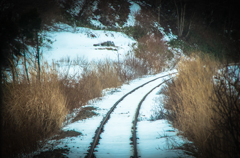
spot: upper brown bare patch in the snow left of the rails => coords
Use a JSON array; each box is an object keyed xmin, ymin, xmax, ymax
[{"xmin": 72, "ymin": 107, "xmax": 98, "ymax": 122}]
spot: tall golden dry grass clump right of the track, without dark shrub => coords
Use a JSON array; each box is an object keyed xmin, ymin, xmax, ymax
[{"xmin": 165, "ymin": 53, "xmax": 216, "ymax": 141}]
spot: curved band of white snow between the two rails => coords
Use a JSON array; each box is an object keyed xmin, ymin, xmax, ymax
[{"xmin": 94, "ymin": 76, "xmax": 174, "ymax": 157}]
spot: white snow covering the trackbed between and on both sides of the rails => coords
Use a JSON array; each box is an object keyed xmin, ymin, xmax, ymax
[{"xmin": 32, "ymin": 70, "xmax": 191, "ymax": 158}]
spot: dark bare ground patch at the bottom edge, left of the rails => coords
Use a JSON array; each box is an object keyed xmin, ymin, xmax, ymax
[{"xmin": 33, "ymin": 148, "xmax": 69, "ymax": 158}]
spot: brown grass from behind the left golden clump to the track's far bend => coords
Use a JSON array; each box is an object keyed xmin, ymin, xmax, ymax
[{"xmin": 56, "ymin": 54, "xmax": 154, "ymax": 111}]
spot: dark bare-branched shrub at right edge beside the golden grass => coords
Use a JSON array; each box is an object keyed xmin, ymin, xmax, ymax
[{"xmin": 211, "ymin": 65, "xmax": 240, "ymax": 157}]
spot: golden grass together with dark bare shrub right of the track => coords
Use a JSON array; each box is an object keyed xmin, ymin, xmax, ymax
[{"xmin": 163, "ymin": 55, "xmax": 240, "ymax": 157}]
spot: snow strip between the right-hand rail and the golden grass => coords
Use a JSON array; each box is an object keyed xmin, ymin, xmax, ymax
[{"xmin": 137, "ymin": 88, "xmax": 186, "ymax": 158}]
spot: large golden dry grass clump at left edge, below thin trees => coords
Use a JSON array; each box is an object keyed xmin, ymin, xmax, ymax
[{"xmin": 1, "ymin": 60, "xmax": 68, "ymax": 157}]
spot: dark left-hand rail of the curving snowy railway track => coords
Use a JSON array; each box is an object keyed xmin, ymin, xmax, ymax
[{"xmin": 86, "ymin": 72, "xmax": 176, "ymax": 158}]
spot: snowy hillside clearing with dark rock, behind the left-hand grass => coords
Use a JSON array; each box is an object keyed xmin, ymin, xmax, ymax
[{"xmin": 43, "ymin": 24, "xmax": 136, "ymax": 63}]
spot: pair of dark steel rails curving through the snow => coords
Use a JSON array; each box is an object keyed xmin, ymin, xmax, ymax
[{"xmin": 86, "ymin": 73, "xmax": 176, "ymax": 158}]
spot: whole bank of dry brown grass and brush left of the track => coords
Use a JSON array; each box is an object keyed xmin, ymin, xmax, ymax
[{"xmin": 2, "ymin": 47, "xmax": 167, "ymax": 157}]
